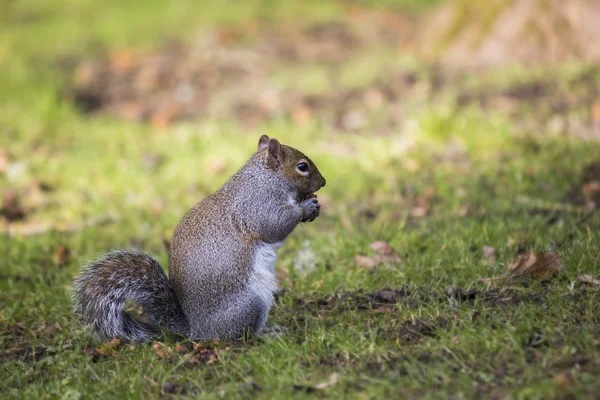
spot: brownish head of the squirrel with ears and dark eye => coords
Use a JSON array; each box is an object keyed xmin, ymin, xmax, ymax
[{"xmin": 258, "ymin": 135, "xmax": 326, "ymax": 201}]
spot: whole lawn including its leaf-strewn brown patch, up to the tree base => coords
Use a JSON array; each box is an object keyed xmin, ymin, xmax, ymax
[{"xmin": 0, "ymin": 0, "xmax": 600, "ymax": 399}]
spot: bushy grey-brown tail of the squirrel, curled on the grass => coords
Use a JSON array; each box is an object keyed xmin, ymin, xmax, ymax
[{"xmin": 72, "ymin": 250, "xmax": 189, "ymax": 341}]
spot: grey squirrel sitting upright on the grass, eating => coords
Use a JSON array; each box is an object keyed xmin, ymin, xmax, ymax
[{"xmin": 72, "ymin": 135, "xmax": 326, "ymax": 342}]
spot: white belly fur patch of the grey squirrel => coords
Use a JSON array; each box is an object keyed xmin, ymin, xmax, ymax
[{"xmin": 250, "ymin": 242, "xmax": 282, "ymax": 310}]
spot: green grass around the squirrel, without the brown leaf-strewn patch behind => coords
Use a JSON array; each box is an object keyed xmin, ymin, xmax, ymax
[{"xmin": 0, "ymin": 0, "xmax": 600, "ymax": 399}]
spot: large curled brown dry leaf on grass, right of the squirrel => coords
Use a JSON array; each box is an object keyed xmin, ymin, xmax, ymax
[{"xmin": 482, "ymin": 251, "xmax": 562, "ymax": 284}]
